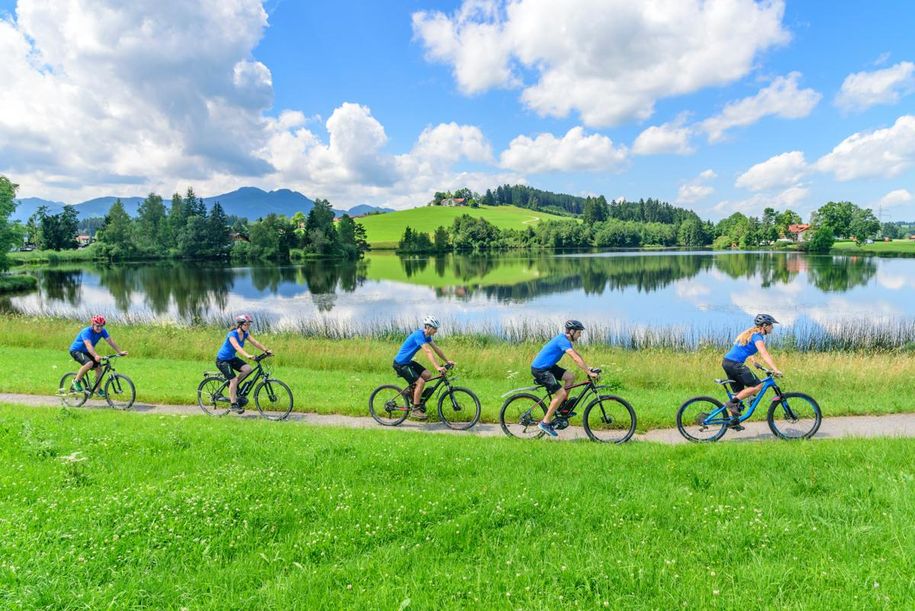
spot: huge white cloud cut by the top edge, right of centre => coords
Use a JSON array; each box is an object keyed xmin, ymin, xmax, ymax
[{"xmin": 413, "ymin": 0, "xmax": 789, "ymax": 126}]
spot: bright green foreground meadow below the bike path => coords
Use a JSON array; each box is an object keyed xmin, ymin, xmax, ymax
[{"xmin": 0, "ymin": 405, "xmax": 915, "ymax": 609}]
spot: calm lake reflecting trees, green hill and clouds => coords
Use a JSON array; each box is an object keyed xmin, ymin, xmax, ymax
[{"xmin": 7, "ymin": 252, "xmax": 915, "ymax": 342}]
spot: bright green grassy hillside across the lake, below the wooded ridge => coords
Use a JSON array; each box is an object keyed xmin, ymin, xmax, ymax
[{"xmin": 358, "ymin": 206, "xmax": 572, "ymax": 248}]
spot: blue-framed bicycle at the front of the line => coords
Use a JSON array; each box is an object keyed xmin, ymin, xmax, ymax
[{"xmin": 677, "ymin": 363, "xmax": 823, "ymax": 442}]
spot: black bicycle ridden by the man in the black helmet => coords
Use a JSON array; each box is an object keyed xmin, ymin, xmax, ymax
[{"xmin": 499, "ymin": 368, "xmax": 636, "ymax": 444}]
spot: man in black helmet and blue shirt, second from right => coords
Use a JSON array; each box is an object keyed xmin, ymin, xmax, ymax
[{"xmin": 531, "ymin": 320, "xmax": 598, "ymax": 437}]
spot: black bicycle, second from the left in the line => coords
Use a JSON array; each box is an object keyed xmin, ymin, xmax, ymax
[{"xmin": 197, "ymin": 352, "xmax": 293, "ymax": 421}]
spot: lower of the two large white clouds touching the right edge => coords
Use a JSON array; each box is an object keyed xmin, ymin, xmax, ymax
[{"xmin": 815, "ymin": 115, "xmax": 915, "ymax": 182}]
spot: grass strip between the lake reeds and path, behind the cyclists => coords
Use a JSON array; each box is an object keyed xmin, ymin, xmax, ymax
[{"xmin": 0, "ymin": 316, "xmax": 915, "ymax": 431}]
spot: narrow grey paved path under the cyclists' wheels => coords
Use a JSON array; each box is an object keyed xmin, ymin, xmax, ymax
[{"xmin": 0, "ymin": 393, "xmax": 915, "ymax": 444}]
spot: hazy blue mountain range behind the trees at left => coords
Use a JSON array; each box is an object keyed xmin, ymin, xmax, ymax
[{"xmin": 11, "ymin": 187, "xmax": 391, "ymax": 222}]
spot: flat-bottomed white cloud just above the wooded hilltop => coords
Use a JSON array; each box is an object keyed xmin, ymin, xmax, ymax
[{"xmin": 500, "ymin": 127, "xmax": 628, "ymax": 174}]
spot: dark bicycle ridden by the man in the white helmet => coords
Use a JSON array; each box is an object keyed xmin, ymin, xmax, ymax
[{"xmin": 369, "ymin": 364, "xmax": 480, "ymax": 431}]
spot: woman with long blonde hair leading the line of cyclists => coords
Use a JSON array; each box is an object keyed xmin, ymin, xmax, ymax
[{"xmin": 721, "ymin": 314, "xmax": 782, "ymax": 431}]
